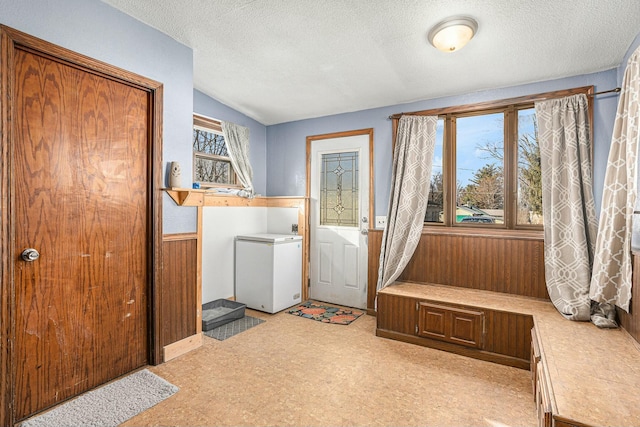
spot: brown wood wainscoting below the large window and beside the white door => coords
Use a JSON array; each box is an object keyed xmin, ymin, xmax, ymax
[{"xmin": 367, "ymin": 227, "xmax": 549, "ymax": 312}]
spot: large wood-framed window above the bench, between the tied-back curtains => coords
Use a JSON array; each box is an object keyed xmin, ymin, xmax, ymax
[{"xmin": 420, "ymin": 86, "xmax": 592, "ymax": 229}]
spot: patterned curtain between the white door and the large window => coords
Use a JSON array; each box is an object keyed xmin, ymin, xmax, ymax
[{"xmin": 377, "ymin": 116, "xmax": 438, "ymax": 290}]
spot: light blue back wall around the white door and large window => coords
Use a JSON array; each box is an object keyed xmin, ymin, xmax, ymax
[{"xmin": 267, "ymin": 69, "xmax": 618, "ymax": 215}]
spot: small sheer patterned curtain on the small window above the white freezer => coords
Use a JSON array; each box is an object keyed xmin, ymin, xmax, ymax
[{"xmin": 221, "ymin": 122, "xmax": 253, "ymax": 197}]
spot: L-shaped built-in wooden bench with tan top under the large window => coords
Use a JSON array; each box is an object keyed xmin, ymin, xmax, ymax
[{"xmin": 376, "ymin": 282, "xmax": 640, "ymax": 427}]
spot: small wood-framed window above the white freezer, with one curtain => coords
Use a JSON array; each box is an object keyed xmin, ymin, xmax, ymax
[{"xmin": 193, "ymin": 114, "xmax": 239, "ymax": 188}]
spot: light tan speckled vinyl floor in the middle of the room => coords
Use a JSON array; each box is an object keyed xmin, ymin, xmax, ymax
[{"xmin": 123, "ymin": 310, "xmax": 536, "ymax": 426}]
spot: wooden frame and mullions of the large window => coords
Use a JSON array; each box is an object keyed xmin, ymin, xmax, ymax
[{"xmin": 389, "ymin": 85, "xmax": 594, "ymax": 231}]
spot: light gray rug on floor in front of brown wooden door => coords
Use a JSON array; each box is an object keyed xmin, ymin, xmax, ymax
[{"xmin": 20, "ymin": 369, "xmax": 178, "ymax": 427}]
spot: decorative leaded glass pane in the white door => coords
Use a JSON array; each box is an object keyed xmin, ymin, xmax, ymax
[{"xmin": 320, "ymin": 151, "xmax": 360, "ymax": 227}]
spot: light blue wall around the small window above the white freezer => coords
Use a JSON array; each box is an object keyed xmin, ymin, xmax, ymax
[{"xmin": 193, "ymin": 89, "xmax": 267, "ymax": 195}]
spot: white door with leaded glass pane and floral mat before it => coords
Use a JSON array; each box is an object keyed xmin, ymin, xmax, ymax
[{"xmin": 309, "ymin": 134, "xmax": 369, "ymax": 309}]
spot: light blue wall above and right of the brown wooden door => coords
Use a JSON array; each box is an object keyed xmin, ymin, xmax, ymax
[{"xmin": 0, "ymin": 0, "xmax": 196, "ymax": 233}]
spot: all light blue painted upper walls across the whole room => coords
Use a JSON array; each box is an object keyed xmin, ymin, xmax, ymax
[{"xmin": 0, "ymin": 0, "xmax": 640, "ymax": 227}]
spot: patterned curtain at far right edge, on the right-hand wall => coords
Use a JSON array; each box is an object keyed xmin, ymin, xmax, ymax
[{"xmin": 589, "ymin": 49, "xmax": 640, "ymax": 312}]
